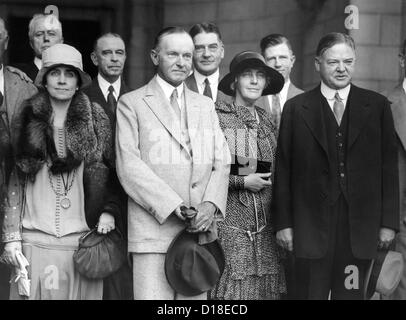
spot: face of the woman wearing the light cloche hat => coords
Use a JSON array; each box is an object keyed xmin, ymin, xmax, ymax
[{"xmin": 45, "ymin": 66, "xmax": 78, "ymax": 101}]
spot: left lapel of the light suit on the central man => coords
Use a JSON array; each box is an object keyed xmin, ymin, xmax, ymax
[{"xmin": 144, "ymin": 77, "xmax": 187, "ymax": 150}]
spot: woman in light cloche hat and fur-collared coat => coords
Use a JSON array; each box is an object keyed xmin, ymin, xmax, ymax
[{"xmin": 3, "ymin": 44, "xmax": 119, "ymax": 300}]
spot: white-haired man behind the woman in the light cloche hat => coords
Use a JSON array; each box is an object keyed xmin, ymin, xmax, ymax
[{"xmin": 15, "ymin": 13, "xmax": 63, "ymax": 81}]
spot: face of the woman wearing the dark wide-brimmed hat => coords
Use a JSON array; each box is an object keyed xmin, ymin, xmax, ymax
[{"xmin": 235, "ymin": 68, "xmax": 267, "ymax": 102}]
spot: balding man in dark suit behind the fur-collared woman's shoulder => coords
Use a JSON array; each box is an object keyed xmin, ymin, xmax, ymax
[{"xmin": 83, "ymin": 33, "xmax": 133, "ymax": 300}]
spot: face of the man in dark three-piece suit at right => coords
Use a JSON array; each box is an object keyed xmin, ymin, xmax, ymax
[{"xmin": 315, "ymin": 43, "xmax": 355, "ymax": 90}]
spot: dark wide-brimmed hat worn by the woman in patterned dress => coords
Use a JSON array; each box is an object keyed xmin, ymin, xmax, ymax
[{"xmin": 218, "ymin": 51, "xmax": 285, "ymax": 96}]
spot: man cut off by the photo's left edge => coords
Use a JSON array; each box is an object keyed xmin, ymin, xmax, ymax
[{"xmin": 0, "ymin": 18, "xmax": 37, "ymax": 300}]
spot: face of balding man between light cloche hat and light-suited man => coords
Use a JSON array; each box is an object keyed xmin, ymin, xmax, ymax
[{"xmin": 91, "ymin": 36, "xmax": 126, "ymax": 83}]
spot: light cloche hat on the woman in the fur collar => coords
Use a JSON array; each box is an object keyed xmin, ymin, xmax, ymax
[{"xmin": 34, "ymin": 43, "xmax": 92, "ymax": 89}]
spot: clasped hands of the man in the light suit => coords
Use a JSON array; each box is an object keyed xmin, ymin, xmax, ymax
[{"xmin": 174, "ymin": 201, "xmax": 216, "ymax": 233}]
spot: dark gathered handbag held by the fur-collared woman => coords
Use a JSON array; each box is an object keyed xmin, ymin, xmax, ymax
[{"xmin": 73, "ymin": 229, "xmax": 127, "ymax": 279}]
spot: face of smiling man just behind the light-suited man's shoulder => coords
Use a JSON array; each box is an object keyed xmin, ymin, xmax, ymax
[{"xmin": 193, "ymin": 32, "xmax": 224, "ymax": 76}]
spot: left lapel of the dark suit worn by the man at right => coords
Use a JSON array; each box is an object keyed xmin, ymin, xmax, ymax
[{"xmin": 301, "ymin": 86, "xmax": 328, "ymax": 157}]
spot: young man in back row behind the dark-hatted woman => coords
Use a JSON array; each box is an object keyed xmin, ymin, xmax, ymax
[{"xmin": 258, "ymin": 33, "xmax": 303, "ymax": 128}]
